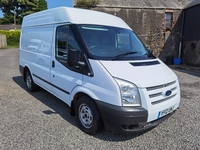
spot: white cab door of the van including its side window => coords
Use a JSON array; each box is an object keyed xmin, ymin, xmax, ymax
[{"xmin": 51, "ymin": 25, "xmax": 83, "ymax": 105}]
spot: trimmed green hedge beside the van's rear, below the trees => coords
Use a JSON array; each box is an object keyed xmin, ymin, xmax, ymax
[{"xmin": 0, "ymin": 30, "xmax": 20, "ymax": 47}]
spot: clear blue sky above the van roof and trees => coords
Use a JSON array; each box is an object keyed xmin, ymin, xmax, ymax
[{"xmin": 0, "ymin": 0, "xmax": 73, "ymax": 18}]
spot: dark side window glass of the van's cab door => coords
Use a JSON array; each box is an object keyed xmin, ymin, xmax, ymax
[{"xmin": 55, "ymin": 25, "xmax": 80, "ymax": 65}]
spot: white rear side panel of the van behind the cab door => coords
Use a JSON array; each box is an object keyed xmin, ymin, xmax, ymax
[{"xmin": 19, "ymin": 25, "xmax": 53, "ymax": 90}]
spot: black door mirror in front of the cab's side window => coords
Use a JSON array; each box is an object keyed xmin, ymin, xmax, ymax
[{"xmin": 67, "ymin": 49, "xmax": 85, "ymax": 68}]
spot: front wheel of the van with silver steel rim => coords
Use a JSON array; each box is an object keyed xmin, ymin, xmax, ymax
[{"xmin": 76, "ymin": 97, "xmax": 102, "ymax": 135}]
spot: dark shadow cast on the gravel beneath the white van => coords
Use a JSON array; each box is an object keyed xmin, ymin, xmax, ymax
[{"xmin": 12, "ymin": 76, "xmax": 153, "ymax": 142}]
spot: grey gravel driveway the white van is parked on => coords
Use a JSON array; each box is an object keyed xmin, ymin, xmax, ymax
[{"xmin": 0, "ymin": 49, "xmax": 200, "ymax": 150}]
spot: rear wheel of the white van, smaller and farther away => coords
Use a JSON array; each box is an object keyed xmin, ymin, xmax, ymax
[{"xmin": 25, "ymin": 70, "xmax": 37, "ymax": 92}]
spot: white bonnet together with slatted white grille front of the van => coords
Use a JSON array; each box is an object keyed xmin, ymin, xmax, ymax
[{"xmin": 100, "ymin": 59, "xmax": 180, "ymax": 122}]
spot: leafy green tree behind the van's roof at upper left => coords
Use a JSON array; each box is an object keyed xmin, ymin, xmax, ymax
[{"xmin": 0, "ymin": 0, "xmax": 47, "ymax": 24}]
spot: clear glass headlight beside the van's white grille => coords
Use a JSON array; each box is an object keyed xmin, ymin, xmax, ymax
[{"xmin": 114, "ymin": 78, "xmax": 141, "ymax": 106}]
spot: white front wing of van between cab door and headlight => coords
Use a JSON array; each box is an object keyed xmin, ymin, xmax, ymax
[{"xmin": 82, "ymin": 59, "xmax": 122, "ymax": 106}]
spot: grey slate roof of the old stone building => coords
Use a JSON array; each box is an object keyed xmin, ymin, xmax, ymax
[{"xmin": 98, "ymin": 0, "xmax": 192, "ymax": 9}]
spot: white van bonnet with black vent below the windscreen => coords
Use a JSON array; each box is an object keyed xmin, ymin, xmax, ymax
[{"xmin": 100, "ymin": 58, "xmax": 177, "ymax": 88}]
